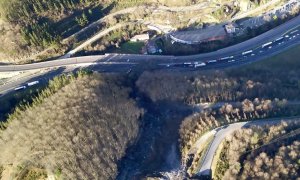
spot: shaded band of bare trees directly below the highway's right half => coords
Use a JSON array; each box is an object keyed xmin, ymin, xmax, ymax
[{"xmin": 137, "ymin": 67, "xmax": 300, "ymax": 105}]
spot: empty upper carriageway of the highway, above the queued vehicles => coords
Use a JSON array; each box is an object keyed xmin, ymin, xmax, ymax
[{"xmin": 0, "ymin": 16, "xmax": 300, "ymax": 72}]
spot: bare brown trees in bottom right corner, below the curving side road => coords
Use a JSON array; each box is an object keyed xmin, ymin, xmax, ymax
[{"xmin": 215, "ymin": 121, "xmax": 300, "ymax": 179}]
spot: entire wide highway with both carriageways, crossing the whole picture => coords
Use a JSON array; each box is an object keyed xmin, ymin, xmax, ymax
[{"xmin": 0, "ymin": 16, "xmax": 300, "ymax": 97}]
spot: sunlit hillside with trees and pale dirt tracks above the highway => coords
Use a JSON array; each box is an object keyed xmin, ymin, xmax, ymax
[{"xmin": 0, "ymin": 0, "xmax": 282, "ymax": 63}]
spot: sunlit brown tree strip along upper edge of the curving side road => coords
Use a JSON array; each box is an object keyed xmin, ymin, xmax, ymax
[{"xmin": 179, "ymin": 98, "xmax": 299, "ymax": 157}]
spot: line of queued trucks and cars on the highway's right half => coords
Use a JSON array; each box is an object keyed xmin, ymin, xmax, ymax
[{"xmin": 165, "ymin": 29, "xmax": 300, "ymax": 68}]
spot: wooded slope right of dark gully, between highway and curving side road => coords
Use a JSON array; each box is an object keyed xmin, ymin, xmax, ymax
[{"xmin": 136, "ymin": 46, "xmax": 300, "ymax": 177}]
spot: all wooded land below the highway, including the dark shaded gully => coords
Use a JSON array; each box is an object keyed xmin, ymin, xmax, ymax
[{"xmin": 0, "ymin": 35, "xmax": 300, "ymax": 179}]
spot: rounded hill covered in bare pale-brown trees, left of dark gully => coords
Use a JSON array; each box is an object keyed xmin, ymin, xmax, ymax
[{"xmin": 0, "ymin": 74, "xmax": 142, "ymax": 179}]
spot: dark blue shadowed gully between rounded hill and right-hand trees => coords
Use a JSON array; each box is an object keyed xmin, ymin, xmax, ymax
[{"xmin": 117, "ymin": 92, "xmax": 192, "ymax": 180}]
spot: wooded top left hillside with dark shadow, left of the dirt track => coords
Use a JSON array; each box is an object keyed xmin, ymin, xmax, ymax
[{"xmin": 0, "ymin": 0, "xmax": 191, "ymax": 63}]
